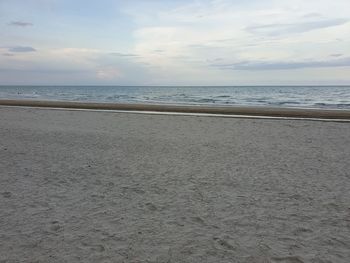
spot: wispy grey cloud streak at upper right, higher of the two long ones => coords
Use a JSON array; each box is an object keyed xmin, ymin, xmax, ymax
[{"xmin": 246, "ymin": 19, "xmax": 349, "ymax": 36}]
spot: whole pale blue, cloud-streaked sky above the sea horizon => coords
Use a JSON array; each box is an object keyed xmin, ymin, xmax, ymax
[{"xmin": 0, "ymin": 0, "xmax": 350, "ymax": 85}]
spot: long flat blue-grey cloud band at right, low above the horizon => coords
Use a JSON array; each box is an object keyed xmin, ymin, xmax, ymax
[{"xmin": 210, "ymin": 57, "xmax": 350, "ymax": 71}]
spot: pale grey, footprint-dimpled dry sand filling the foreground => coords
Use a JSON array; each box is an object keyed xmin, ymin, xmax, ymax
[{"xmin": 0, "ymin": 107, "xmax": 350, "ymax": 263}]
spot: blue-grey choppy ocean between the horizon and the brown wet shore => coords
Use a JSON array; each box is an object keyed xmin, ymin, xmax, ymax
[{"xmin": 0, "ymin": 86, "xmax": 350, "ymax": 109}]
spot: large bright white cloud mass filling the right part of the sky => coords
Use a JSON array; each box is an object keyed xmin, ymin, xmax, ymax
[{"xmin": 122, "ymin": 0, "xmax": 350, "ymax": 82}]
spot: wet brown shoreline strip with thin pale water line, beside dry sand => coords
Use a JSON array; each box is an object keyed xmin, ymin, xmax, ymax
[{"xmin": 0, "ymin": 99, "xmax": 350, "ymax": 120}]
